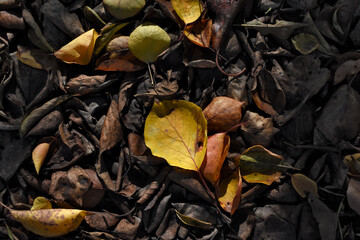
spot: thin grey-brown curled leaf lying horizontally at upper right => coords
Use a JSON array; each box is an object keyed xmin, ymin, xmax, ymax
[{"xmin": 241, "ymin": 19, "xmax": 309, "ymax": 39}]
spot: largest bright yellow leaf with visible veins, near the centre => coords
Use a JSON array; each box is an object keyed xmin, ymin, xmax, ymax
[{"xmin": 144, "ymin": 100, "xmax": 207, "ymax": 171}]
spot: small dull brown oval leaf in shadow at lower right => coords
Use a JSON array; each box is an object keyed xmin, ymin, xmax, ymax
[{"xmin": 291, "ymin": 173, "xmax": 319, "ymax": 198}]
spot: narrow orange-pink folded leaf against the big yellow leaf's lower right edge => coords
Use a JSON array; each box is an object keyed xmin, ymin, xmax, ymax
[{"xmin": 200, "ymin": 133, "xmax": 230, "ymax": 185}]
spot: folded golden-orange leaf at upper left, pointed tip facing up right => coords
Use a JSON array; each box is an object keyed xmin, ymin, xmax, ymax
[{"xmin": 55, "ymin": 29, "xmax": 99, "ymax": 65}]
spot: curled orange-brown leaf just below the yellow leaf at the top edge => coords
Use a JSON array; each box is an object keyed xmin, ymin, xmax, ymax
[{"xmin": 184, "ymin": 19, "xmax": 212, "ymax": 47}]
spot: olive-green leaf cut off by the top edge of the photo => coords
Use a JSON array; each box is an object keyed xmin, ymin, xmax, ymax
[{"xmin": 103, "ymin": 0, "xmax": 146, "ymax": 20}]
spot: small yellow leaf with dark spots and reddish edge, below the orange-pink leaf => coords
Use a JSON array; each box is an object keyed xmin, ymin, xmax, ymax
[{"xmin": 216, "ymin": 169, "xmax": 242, "ymax": 215}]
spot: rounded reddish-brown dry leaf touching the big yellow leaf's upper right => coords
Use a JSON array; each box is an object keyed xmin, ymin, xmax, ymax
[{"xmin": 203, "ymin": 97, "xmax": 244, "ymax": 132}]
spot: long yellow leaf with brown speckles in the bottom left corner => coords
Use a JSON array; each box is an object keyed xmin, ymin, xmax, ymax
[{"xmin": 10, "ymin": 209, "xmax": 89, "ymax": 237}]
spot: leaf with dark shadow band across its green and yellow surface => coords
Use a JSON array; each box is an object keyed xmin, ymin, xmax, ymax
[{"xmin": 236, "ymin": 145, "xmax": 286, "ymax": 185}]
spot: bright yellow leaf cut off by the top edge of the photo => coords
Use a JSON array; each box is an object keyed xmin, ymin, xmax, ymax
[{"xmin": 171, "ymin": 0, "xmax": 202, "ymax": 24}]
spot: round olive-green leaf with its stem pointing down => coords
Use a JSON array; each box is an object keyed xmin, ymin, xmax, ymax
[{"xmin": 129, "ymin": 23, "xmax": 171, "ymax": 63}]
